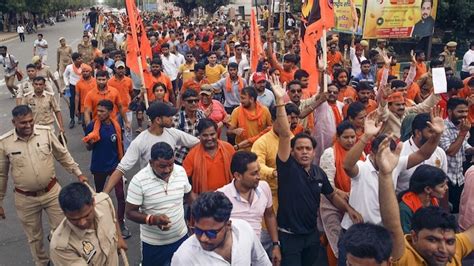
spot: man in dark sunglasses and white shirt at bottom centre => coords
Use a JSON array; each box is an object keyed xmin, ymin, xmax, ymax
[{"xmin": 171, "ymin": 192, "xmax": 272, "ymax": 266}]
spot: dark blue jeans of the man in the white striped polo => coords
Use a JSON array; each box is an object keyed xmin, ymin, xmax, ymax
[{"xmin": 142, "ymin": 235, "xmax": 188, "ymax": 266}]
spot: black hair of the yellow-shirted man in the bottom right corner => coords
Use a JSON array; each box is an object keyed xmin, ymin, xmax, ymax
[{"xmin": 411, "ymin": 206, "xmax": 458, "ymax": 233}]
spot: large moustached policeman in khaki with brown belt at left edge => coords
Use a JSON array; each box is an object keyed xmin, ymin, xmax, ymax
[{"xmin": 0, "ymin": 105, "xmax": 87, "ymax": 265}]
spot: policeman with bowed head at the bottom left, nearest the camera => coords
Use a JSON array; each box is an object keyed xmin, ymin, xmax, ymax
[{"xmin": 50, "ymin": 182, "xmax": 127, "ymax": 266}]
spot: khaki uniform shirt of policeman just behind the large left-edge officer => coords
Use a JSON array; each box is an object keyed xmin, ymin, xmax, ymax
[{"xmin": 21, "ymin": 91, "xmax": 61, "ymax": 130}]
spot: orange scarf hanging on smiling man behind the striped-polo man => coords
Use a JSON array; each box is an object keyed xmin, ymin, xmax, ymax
[{"xmin": 192, "ymin": 140, "xmax": 232, "ymax": 194}]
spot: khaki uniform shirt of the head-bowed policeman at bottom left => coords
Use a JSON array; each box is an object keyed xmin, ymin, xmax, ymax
[{"xmin": 50, "ymin": 193, "xmax": 119, "ymax": 266}]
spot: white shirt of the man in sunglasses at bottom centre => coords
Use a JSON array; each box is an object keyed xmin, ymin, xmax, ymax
[{"xmin": 171, "ymin": 219, "xmax": 272, "ymax": 266}]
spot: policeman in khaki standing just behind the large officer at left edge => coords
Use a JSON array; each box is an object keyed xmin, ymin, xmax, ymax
[{"xmin": 21, "ymin": 76, "xmax": 64, "ymax": 132}]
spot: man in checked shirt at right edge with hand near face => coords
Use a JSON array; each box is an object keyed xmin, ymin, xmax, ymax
[{"xmin": 439, "ymin": 98, "xmax": 474, "ymax": 213}]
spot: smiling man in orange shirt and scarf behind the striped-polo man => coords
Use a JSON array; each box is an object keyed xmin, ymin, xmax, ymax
[{"xmin": 183, "ymin": 118, "xmax": 235, "ymax": 194}]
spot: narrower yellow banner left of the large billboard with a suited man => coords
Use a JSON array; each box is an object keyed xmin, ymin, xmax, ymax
[{"xmin": 333, "ymin": 0, "xmax": 365, "ymax": 35}]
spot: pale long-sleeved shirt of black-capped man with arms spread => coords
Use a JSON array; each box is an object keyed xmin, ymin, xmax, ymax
[{"xmin": 117, "ymin": 128, "xmax": 199, "ymax": 173}]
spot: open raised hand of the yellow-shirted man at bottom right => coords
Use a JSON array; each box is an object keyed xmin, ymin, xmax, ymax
[{"xmin": 375, "ymin": 135, "xmax": 403, "ymax": 176}]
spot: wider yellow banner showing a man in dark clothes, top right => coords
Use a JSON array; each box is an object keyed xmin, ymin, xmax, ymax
[{"xmin": 364, "ymin": 0, "xmax": 438, "ymax": 39}]
